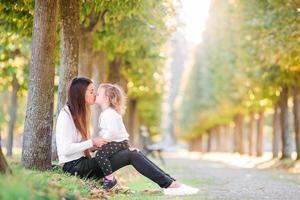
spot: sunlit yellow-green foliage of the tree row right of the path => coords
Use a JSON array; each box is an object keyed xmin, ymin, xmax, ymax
[{"xmin": 179, "ymin": 0, "xmax": 300, "ymax": 138}]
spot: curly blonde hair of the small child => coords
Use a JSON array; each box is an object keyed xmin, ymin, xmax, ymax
[{"xmin": 99, "ymin": 83, "xmax": 127, "ymax": 115}]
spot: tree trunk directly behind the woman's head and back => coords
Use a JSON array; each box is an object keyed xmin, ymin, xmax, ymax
[{"xmin": 52, "ymin": 0, "xmax": 80, "ymax": 160}]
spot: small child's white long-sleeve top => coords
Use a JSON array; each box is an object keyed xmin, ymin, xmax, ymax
[{"xmin": 99, "ymin": 107, "xmax": 129, "ymax": 142}]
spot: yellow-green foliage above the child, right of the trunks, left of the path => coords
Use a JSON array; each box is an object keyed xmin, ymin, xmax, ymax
[{"xmin": 93, "ymin": 0, "xmax": 174, "ymax": 130}]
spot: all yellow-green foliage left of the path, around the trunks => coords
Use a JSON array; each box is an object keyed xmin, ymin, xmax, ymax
[{"xmin": 0, "ymin": 0, "xmax": 174, "ymax": 136}]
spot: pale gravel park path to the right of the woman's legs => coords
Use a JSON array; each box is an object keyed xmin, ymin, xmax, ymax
[{"xmin": 163, "ymin": 154, "xmax": 300, "ymax": 200}]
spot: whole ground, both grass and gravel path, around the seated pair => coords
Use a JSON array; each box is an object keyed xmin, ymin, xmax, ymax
[{"xmin": 0, "ymin": 152, "xmax": 300, "ymax": 200}]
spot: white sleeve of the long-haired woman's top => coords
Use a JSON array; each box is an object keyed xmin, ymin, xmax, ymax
[{"xmin": 56, "ymin": 110, "xmax": 93, "ymax": 156}]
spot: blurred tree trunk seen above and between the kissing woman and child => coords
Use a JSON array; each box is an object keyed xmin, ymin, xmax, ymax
[{"xmin": 92, "ymin": 51, "xmax": 107, "ymax": 136}]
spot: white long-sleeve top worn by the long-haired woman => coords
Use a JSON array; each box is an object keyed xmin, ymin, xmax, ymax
[{"xmin": 55, "ymin": 105, "xmax": 93, "ymax": 164}]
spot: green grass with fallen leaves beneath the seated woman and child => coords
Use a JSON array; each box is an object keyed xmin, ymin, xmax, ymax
[{"xmin": 0, "ymin": 156, "xmax": 212, "ymax": 200}]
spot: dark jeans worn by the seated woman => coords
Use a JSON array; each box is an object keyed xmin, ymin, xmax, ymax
[{"xmin": 63, "ymin": 149, "xmax": 175, "ymax": 188}]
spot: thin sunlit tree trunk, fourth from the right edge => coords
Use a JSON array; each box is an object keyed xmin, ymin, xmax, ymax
[{"xmin": 256, "ymin": 110, "xmax": 265, "ymax": 156}]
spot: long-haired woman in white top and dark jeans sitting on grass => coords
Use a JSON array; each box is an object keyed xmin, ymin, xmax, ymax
[{"xmin": 56, "ymin": 78, "xmax": 198, "ymax": 195}]
